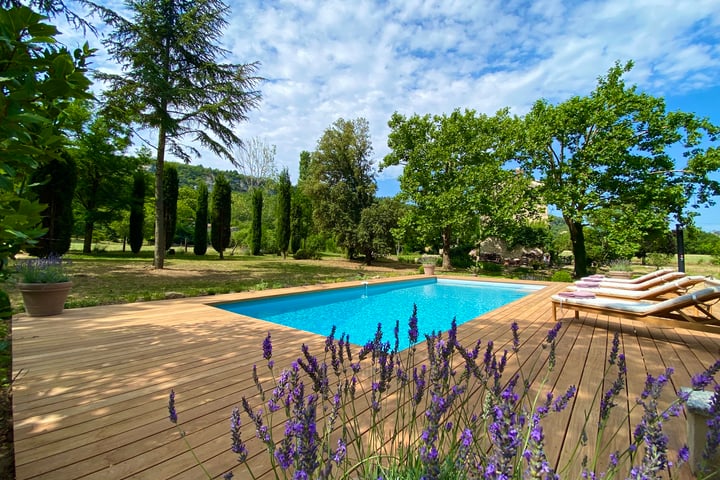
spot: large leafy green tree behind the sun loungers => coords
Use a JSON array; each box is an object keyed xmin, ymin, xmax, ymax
[{"xmin": 521, "ymin": 62, "xmax": 720, "ymax": 277}]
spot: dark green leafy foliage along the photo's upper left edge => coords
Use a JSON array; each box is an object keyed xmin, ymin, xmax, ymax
[{"xmin": 0, "ymin": 6, "xmax": 93, "ymax": 271}]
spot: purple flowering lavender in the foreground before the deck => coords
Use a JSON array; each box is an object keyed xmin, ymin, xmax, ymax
[{"xmin": 170, "ymin": 308, "xmax": 720, "ymax": 480}]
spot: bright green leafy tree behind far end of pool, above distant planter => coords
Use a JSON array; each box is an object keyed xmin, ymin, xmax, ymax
[{"xmin": 381, "ymin": 110, "xmax": 531, "ymax": 267}]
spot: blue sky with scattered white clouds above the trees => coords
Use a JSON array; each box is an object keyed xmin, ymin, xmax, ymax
[{"xmin": 59, "ymin": 0, "xmax": 720, "ymax": 231}]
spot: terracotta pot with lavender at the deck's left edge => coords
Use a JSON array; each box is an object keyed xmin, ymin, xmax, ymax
[{"xmin": 15, "ymin": 256, "xmax": 72, "ymax": 317}]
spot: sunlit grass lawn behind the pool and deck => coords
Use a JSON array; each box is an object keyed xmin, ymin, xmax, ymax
[{"xmin": 5, "ymin": 242, "xmax": 720, "ymax": 312}]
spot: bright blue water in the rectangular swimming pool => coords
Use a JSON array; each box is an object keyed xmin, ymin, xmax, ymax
[{"xmin": 216, "ymin": 278, "xmax": 543, "ymax": 350}]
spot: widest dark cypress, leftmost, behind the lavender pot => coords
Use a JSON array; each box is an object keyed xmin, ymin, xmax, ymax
[{"xmin": 28, "ymin": 154, "xmax": 77, "ymax": 257}]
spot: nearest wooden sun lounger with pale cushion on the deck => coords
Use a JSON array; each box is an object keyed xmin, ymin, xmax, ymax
[{"xmin": 550, "ymin": 287, "xmax": 720, "ymax": 326}]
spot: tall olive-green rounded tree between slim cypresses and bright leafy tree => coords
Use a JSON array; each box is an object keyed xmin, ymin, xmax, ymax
[{"xmin": 302, "ymin": 118, "xmax": 377, "ymax": 258}]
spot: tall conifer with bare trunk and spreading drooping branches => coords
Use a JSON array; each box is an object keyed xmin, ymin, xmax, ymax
[{"xmin": 94, "ymin": 0, "xmax": 260, "ymax": 268}]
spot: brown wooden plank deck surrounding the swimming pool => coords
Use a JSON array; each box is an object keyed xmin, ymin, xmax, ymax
[{"xmin": 12, "ymin": 276, "xmax": 720, "ymax": 480}]
